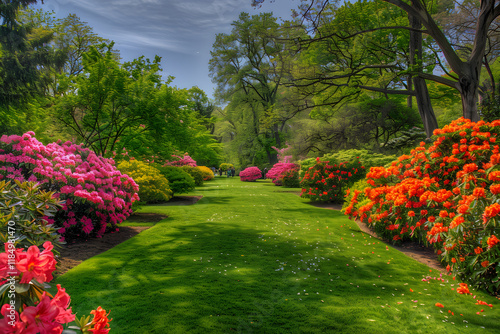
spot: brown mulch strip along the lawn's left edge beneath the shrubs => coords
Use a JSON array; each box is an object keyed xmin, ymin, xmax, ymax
[{"xmin": 55, "ymin": 196, "xmax": 203, "ymax": 276}]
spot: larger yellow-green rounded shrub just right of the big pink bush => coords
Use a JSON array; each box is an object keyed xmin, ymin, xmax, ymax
[{"xmin": 118, "ymin": 160, "xmax": 172, "ymax": 203}]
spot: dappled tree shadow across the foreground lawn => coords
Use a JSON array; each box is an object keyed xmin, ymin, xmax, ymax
[{"xmin": 50, "ymin": 217, "xmax": 472, "ymax": 333}]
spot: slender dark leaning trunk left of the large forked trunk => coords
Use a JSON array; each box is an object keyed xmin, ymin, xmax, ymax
[{"xmin": 408, "ymin": 11, "xmax": 438, "ymax": 138}]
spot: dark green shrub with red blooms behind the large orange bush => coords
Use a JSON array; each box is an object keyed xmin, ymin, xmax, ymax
[{"xmin": 300, "ymin": 158, "xmax": 364, "ymax": 203}]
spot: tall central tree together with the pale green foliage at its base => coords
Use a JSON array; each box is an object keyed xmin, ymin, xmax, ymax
[{"xmin": 209, "ymin": 13, "xmax": 303, "ymax": 167}]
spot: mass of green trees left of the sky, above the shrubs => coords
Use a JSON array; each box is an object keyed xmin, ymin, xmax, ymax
[{"xmin": 0, "ymin": 1, "xmax": 221, "ymax": 166}]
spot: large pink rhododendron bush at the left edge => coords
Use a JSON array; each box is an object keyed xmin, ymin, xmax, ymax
[{"xmin": 0, "ymin": 131, "xmax": 139, "ymax": 240}]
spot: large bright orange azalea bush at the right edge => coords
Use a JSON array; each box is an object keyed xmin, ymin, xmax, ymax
[{"xmin": 345, "ymin": 118, "xmax": 500, "ymax": 294}]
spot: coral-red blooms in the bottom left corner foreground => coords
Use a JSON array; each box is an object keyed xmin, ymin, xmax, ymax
[{"xmin": 0, "ymin": 241, "xmax": 110, "ymax": 334}]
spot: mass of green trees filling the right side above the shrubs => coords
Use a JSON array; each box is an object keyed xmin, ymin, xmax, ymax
[{"xmin": 210, "ymin": 0, "xmax": 500, "ymax": 166}]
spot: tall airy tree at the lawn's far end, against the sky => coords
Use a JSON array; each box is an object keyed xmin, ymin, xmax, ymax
[{"xmin": 209, "ymin": 13, "xmax": 302, "ymax": 163}]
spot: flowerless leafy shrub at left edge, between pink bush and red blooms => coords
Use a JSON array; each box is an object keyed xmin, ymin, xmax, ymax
[{"xmin": 0, "ymin": 180, "xmax": 61, "ymax": 249}]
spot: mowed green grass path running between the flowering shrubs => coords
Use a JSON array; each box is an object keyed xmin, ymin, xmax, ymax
[{"xmin": 53, "ymin": 178, "xmax": 500, "ymax": 333}]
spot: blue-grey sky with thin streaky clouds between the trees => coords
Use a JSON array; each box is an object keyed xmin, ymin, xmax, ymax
[{"xmin": 37, "ymin": 0, "xmax": 300, "ymax": 97}]
